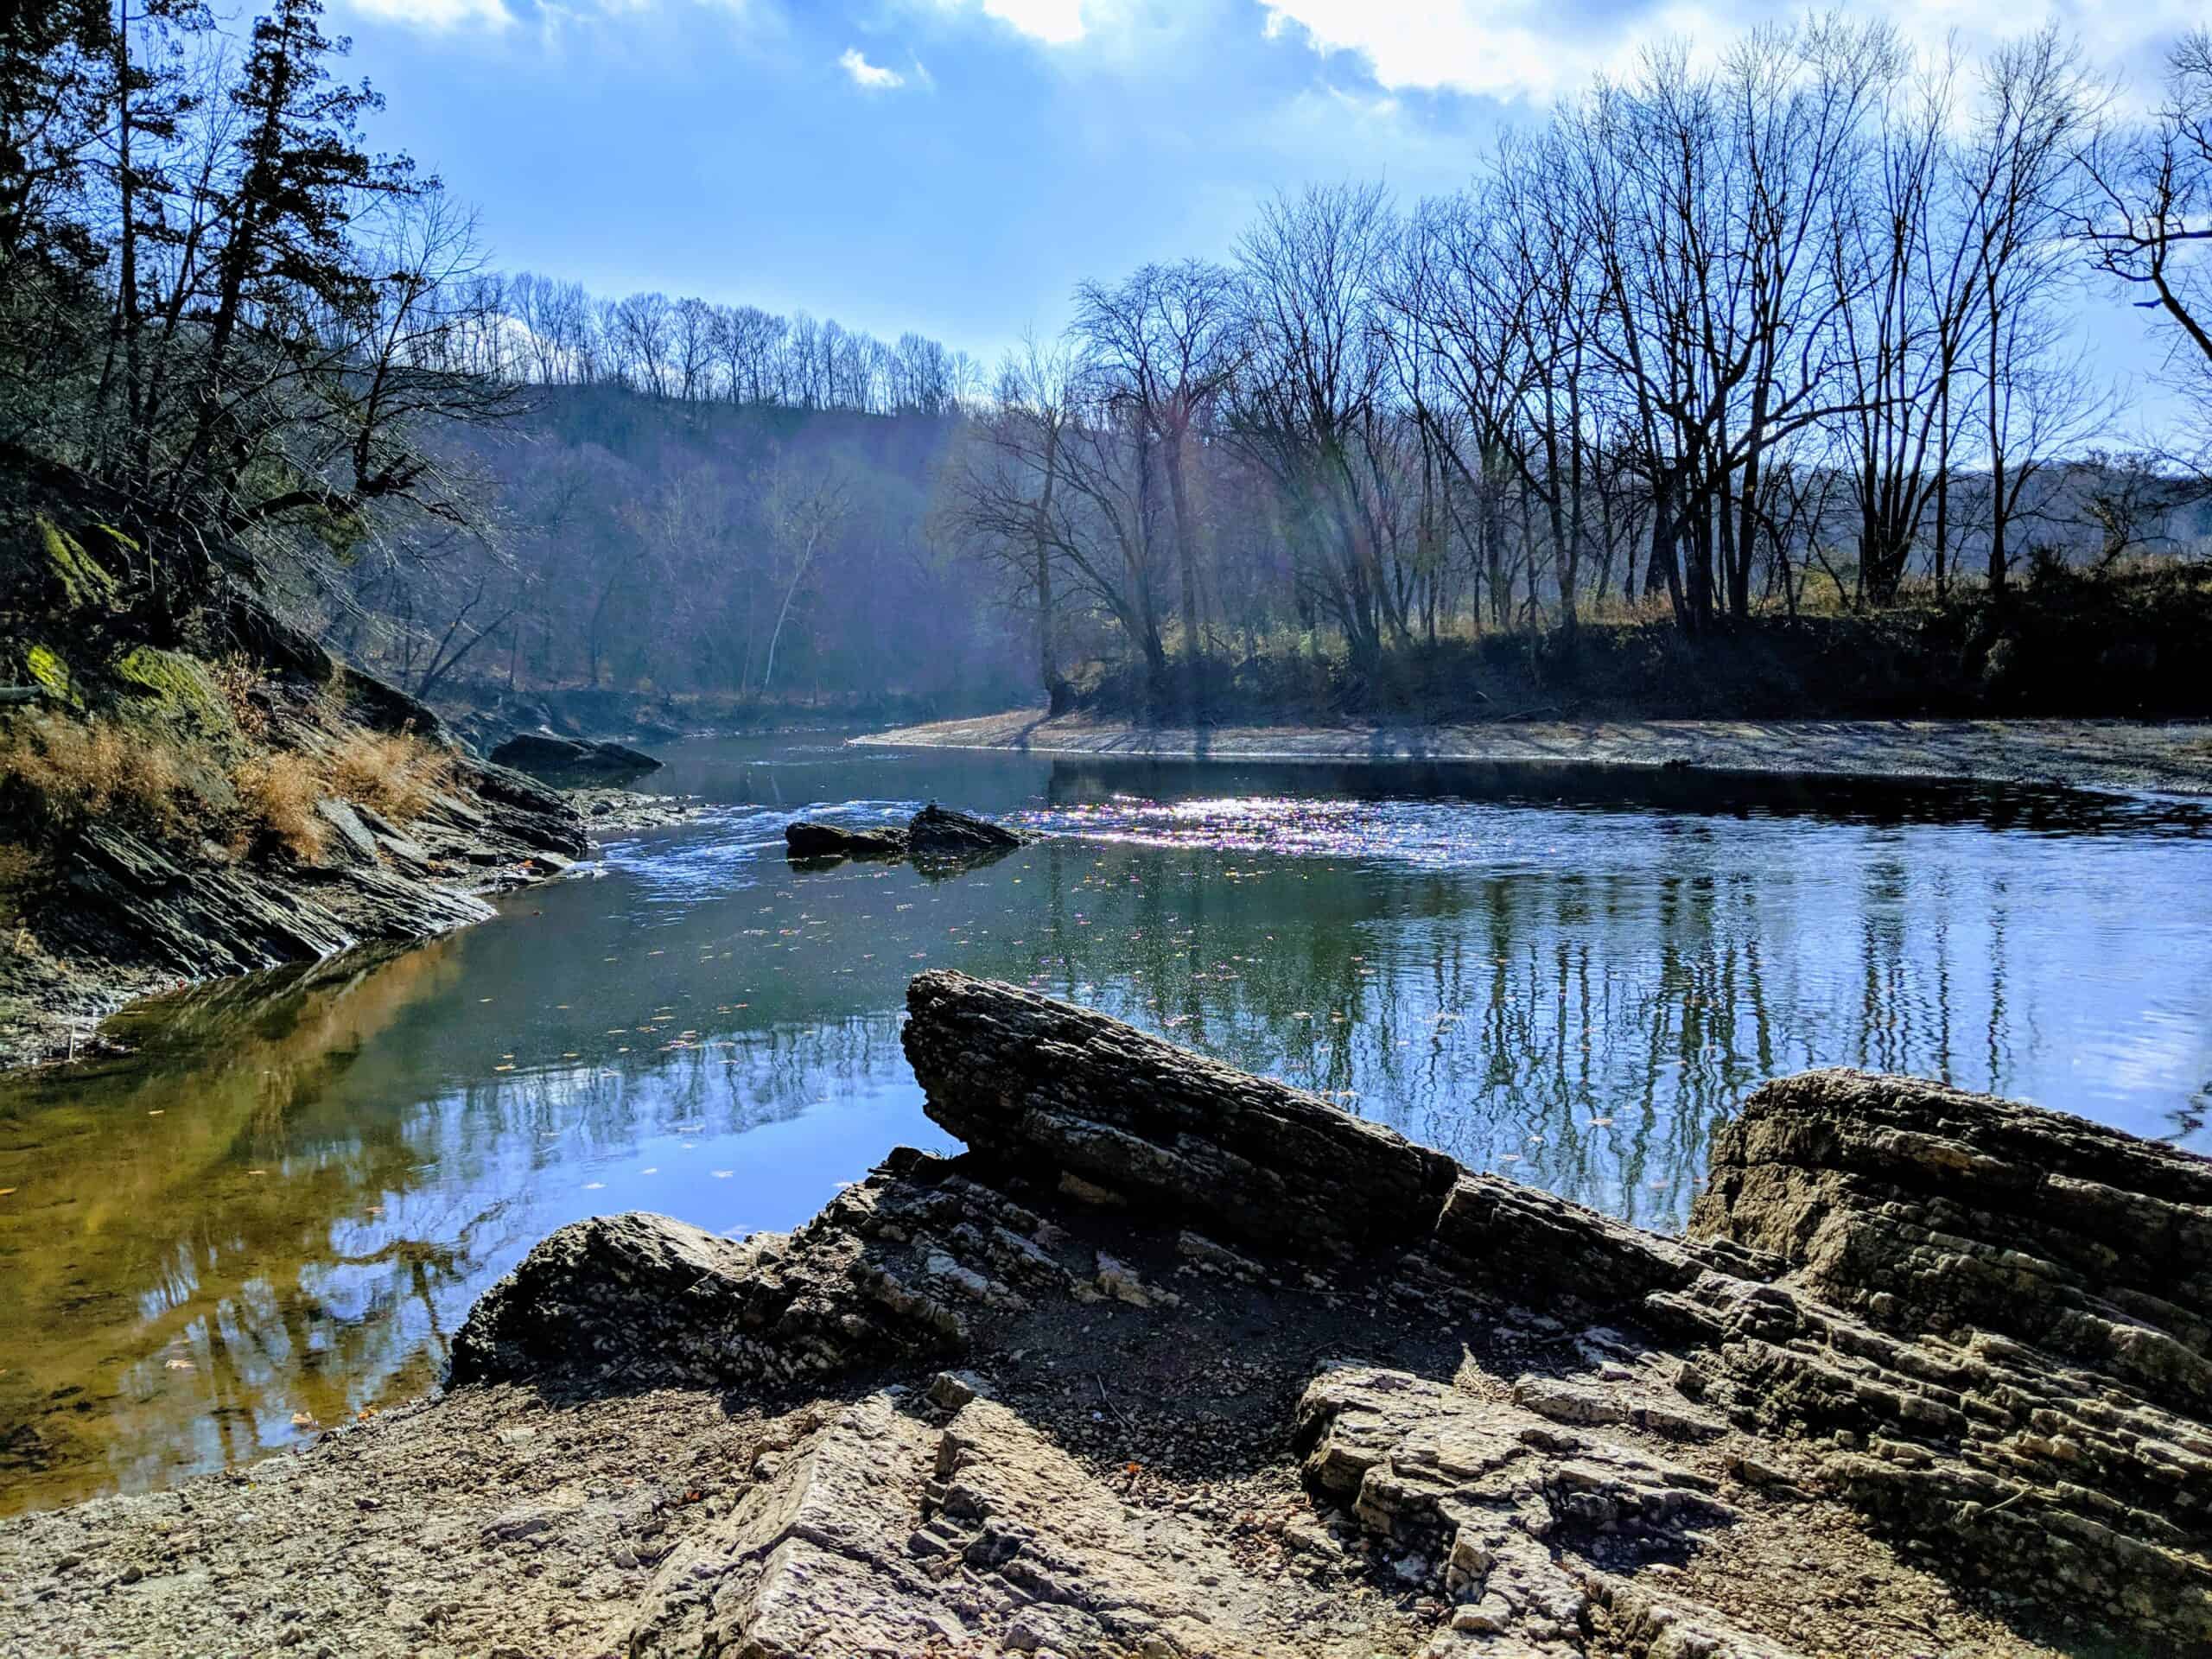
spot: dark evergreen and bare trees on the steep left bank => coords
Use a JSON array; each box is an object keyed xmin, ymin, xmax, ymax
[{"xmin": 0, "ymin": 0, "xmax": 515, "ymax": 644}]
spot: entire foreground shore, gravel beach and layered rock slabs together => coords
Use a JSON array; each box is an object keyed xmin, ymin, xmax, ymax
[{"xmin": 0, "ymin": 971, "xmax": 2212, "ymax": 1659}]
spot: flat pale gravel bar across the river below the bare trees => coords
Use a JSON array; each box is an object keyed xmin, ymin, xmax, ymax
[{"xmin": 849, "ymin": 710, "xmax": 2212, "ymax": 794}]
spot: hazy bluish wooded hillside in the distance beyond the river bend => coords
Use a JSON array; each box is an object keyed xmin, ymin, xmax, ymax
[{"xmin": 325, "ymin": 393, "xmax": 1031, "ymax": 712}]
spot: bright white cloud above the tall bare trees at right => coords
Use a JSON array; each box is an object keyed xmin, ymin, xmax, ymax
[{"xmin": 1259, "ymin": 0, "xmax": 2199, "ymax": 102}]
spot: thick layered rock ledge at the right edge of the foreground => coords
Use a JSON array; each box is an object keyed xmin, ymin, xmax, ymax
[{"xmin": 1650, "ymin": 1071, "xmax": 2212, "ymax": 1643}]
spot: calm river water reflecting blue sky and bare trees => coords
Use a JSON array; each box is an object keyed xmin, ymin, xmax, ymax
[{"xmin": 0, "ymin": 736, "xmax": 2212, "ymax": 1510}]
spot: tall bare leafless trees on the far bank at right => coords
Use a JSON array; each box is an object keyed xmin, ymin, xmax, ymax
[{"xmin": 940, "ymin": 17, "xmax": 2212, "ymax": 696}]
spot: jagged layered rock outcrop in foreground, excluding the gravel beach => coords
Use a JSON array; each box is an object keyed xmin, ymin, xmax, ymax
[{"xmin": 440, "ymin": 971, "xmax": 2212, "ymax": 1659}]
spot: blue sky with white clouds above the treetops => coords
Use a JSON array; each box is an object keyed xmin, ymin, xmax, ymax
[{"xmin": 329, "ymin": 0, "xmax": 2203, "ymax": 376}]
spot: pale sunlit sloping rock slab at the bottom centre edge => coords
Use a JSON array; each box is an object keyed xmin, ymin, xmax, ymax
[{"xmin": 631, "ymin": 1394, "xmax": 1397, "ymax": 1659}]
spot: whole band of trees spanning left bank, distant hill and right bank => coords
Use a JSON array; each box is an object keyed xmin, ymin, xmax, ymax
[{"xmin": 0, "ymin": 0, "xmax": 2212, "ymax": 721}]
